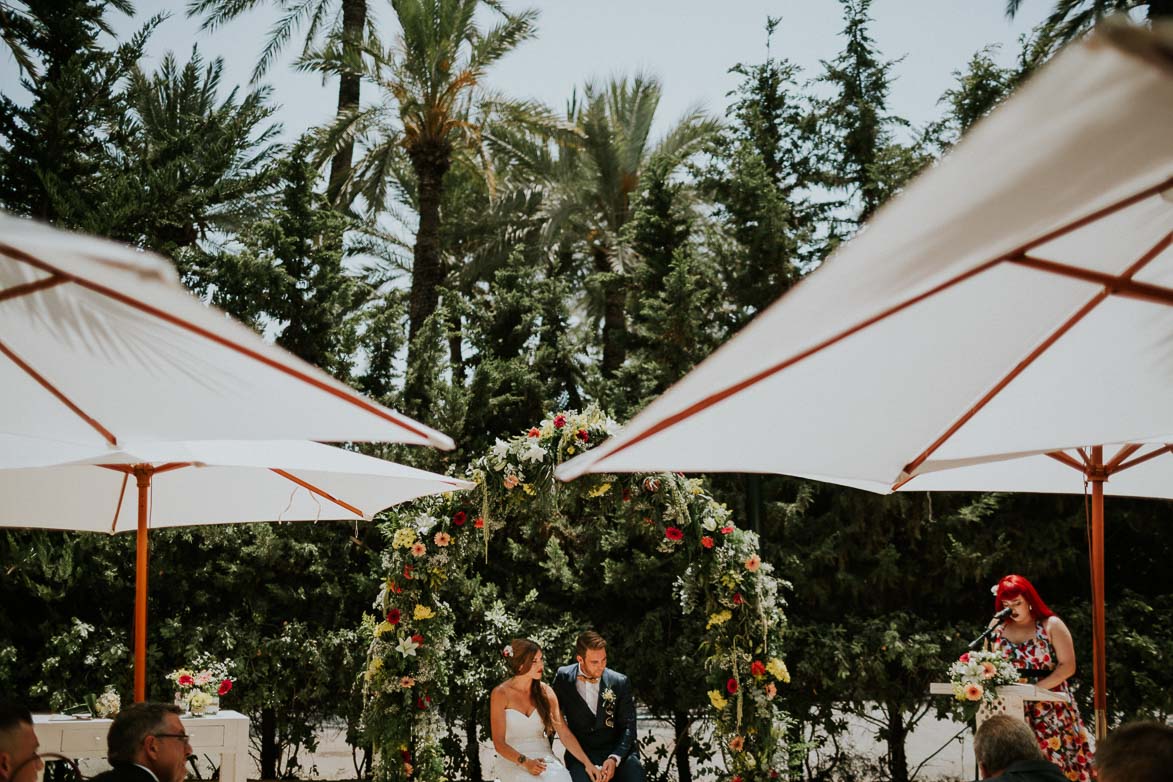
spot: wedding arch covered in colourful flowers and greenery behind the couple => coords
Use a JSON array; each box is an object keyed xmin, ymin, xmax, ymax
[{"xmin": 364, "ymin": 409, "xmax": 789, "ymax": 782}]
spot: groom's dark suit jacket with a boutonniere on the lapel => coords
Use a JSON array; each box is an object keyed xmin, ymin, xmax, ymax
[{"xmin": 554, "ymin": 662, "xmax": 636, "ymax": 767}]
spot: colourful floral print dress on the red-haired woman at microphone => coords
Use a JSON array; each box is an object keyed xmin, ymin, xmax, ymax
[{"xmin": 994, "ymin": 621, "xmax": 1094, "ymax": 782}]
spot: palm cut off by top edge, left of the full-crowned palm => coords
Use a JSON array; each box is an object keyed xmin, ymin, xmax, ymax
[{"xmin": 188, "ymin": 0, "xmax": 375, "ymax": 203}]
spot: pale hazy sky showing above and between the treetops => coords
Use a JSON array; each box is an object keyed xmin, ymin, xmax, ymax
[{"xmin": 0, "ymin": 0, "xmax": 1052, "ymax": 141}]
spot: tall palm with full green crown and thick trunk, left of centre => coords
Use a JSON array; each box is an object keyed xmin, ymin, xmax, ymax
[{"xmin": 299, "ymin": 0, "xmax": 541, "ymax": 408}]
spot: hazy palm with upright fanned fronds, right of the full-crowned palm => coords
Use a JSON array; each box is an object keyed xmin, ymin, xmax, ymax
[{"xmin": 549, "ymin": 75, "xmax": 718, "ymax": 378}]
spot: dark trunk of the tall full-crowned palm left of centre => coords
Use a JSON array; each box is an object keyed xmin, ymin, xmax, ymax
[{"xmin": 404, "ymin": 142, "xmax": 452, "ymax": 415}]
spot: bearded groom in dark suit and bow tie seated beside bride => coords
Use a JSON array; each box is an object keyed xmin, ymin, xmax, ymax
[{"xmin": 554, "ymin": 630, "xmax": 644, "ymax": 782}]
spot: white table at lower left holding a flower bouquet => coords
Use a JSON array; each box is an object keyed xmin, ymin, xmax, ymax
[{"xmin": 33, "ymin": 712, "xmax": 249, "ymax": 782}]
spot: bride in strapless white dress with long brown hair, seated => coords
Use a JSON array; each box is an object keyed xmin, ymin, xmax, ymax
[{"xmin": 489, "ymin": 638, "xmax": 598, "ymax": 782}]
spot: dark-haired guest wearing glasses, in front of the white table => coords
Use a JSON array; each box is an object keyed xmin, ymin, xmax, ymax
[{"xmin": 91, "ymin": 703, "xmax": 191, "ymax": 782}]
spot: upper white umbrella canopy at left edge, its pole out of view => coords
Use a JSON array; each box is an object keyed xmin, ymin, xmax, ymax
[{"xmin": 0, "ymin": 213, "xmax": 453, "ymax": 451}]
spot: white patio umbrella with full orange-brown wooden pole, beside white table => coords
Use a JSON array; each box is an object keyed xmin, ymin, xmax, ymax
[{"xmin": 0, "ymin": 441, "xmax": 475, "ymax": 701}]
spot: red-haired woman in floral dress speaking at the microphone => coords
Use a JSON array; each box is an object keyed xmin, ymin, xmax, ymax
[{"xmin": 992, "ymin": 574, "xmax": 1093, "ymax": 782}]
